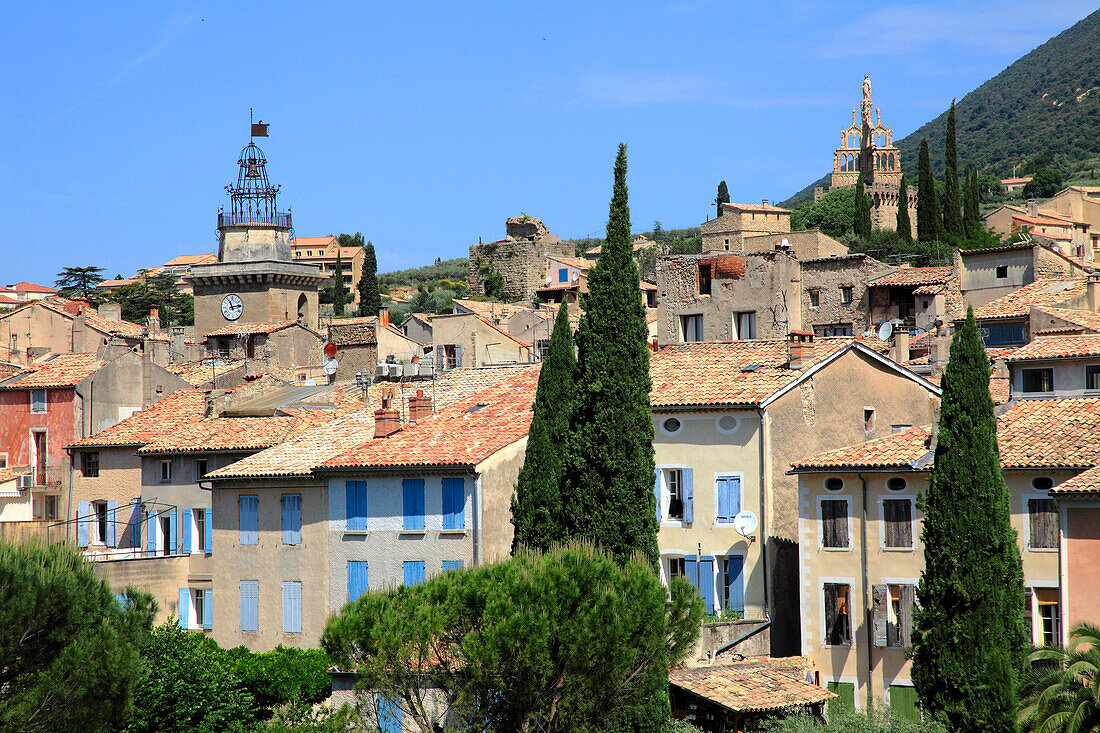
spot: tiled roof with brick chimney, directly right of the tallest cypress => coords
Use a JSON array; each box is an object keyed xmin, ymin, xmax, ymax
[{"xmin": 649, "ymin": 338, "xmax": 853, "ymax": 409}]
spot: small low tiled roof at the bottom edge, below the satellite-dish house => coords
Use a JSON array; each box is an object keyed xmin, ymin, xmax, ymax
[{"xmin": 669, "ymin": 659, "xmax": 837, "ymax": 713}]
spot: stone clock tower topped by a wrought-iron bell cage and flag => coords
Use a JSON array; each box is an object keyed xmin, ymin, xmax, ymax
[{"xmin": 188, "ymin": 134, "xmax": 325, "ymax": 342}]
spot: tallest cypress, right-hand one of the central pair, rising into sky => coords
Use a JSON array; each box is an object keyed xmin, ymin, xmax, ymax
[{"xmin": 562, "ymin": 144, "xmax": 658, "ymax": 570}]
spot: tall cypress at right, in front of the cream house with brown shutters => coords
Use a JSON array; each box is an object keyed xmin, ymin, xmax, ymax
[{"xmin": 913, "ymin": 308, "xmax": 1026, "ymax": 733}]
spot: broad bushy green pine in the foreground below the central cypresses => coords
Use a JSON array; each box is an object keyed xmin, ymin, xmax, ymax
[{"xmin": 321, "ymin": 544, "xmax": 703, "ymax": 733}]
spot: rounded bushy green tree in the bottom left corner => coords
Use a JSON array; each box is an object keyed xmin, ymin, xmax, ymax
[{"xmin": 0, "ymin": 541, "xmax": 151, "ymax": 733}]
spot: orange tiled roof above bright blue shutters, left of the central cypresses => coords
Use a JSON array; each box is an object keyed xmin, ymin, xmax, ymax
[{"xmin": 318, "ymin": 369, "xmax": 538, "ymax": 469}]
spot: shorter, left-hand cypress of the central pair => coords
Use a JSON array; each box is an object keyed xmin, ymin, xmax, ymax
[{"xmin": 512, "ymin": 303, "xmax": 576, "ymax": 554}]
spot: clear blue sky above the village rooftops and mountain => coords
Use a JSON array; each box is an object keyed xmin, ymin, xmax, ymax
[{"xmin": 0, "ymin": 0, "xmax": 1095, "ymax": 284}]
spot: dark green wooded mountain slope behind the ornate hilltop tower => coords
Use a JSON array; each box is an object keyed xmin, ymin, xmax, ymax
[{"xmin": 781, "ymin": 10, "xmax": 1100, "ymax": 208}]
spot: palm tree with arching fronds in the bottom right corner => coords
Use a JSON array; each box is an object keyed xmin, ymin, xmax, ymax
[{"xmin": 1020, "ymin": 624, "xmax": 1100, "ymax": 733}]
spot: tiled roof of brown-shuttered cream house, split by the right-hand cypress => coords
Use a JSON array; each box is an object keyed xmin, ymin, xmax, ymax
[{"xmin": 794, "ymin": 397, "xmax": 1100, "ymax": 471}]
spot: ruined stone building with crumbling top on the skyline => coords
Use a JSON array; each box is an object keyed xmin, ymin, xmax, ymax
[{"xmin": 468, "ymin": 215, "xmax": 575, "ymax": 300}]
